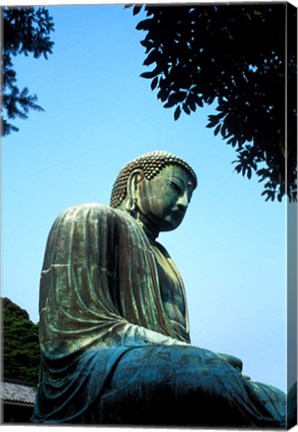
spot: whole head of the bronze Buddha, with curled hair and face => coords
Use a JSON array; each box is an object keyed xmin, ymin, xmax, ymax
[{"xmin": 111, "ymin": 151, "xmax": 197, "ymax": 238}]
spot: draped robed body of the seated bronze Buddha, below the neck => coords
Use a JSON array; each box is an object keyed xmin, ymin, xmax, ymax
[{"xmin": 32, "ymin": 204, "xmax": 284, "ymax": 427}]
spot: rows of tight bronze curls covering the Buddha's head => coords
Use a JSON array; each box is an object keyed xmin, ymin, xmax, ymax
[{"xmin": 110, "ymin": 150, "xmax": 197, "ymax": 208}]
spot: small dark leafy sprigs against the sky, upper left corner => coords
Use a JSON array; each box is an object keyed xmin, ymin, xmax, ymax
[{"xmin": 1, "ymin": 7, "xmax": 54, "ymax": 135}]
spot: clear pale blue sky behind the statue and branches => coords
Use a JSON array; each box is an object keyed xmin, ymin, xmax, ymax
[{"xmin": 2, "ymin": 5, "xmax": 294, "ymax": 389}]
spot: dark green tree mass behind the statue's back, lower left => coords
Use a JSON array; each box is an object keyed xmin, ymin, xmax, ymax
[{"xmin": 1, "ymin": 297, "xmax": 40, "ymax": 383}]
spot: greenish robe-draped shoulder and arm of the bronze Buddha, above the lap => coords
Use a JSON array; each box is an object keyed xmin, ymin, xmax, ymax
[{"xmin": 40, "ymin": 205, "xmax": 189, "ymax": 348}]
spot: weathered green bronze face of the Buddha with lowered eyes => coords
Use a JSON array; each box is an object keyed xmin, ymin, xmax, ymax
[{"xmin": 136, "ymin": 165, "xmax": 194, "ymax": 231}]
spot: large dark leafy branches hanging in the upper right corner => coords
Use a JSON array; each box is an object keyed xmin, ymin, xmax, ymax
[{"xmin": 133, "ymin": 2, "xmax": 297, "ymax": 201}]
